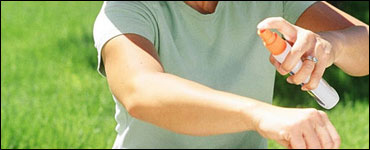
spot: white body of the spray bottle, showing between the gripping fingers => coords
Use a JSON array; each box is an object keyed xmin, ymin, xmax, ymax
[{"xmin": 273, "ymin": 43, "xmax": 339, "ymax": 109}]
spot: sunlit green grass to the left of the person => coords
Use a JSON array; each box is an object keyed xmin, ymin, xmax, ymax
[{"xmin": 1, "ymin": 2, "xmax": 116, "ymax": 148}]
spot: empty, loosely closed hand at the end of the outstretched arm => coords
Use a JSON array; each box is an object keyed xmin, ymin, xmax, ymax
[{"xmin": 256, "ymin": 107, "xmax": 340, "ymax": 149}]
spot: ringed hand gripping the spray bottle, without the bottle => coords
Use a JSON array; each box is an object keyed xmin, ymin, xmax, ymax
[{"xmin": 257, "ymin": 17, "xmax": 335, "ymax": 90}]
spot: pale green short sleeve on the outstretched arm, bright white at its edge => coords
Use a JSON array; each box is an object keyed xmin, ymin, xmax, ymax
[{"xmin": 93, "ymin": 1, "xmax": 155, "ymax": 76}]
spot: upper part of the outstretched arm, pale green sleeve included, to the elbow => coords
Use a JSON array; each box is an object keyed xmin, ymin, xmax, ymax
[{"xmin": 94, "ymin": 1, "xmax": 163, "ymax": 108}]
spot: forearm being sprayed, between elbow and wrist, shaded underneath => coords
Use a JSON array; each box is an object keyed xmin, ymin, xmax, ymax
[{"xmin": 117, "ymin": 73, "xmax": 273, "ymax": 136}]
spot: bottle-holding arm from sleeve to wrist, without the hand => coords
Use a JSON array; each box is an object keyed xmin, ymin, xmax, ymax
[{"xmin": 296, "ymin": 2, "xmax": 369, "ymax": 76}]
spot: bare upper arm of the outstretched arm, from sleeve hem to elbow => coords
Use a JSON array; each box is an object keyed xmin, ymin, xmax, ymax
[{"xmin": 102, "ymin": 34, "xmax": 163, "ymax": 103}]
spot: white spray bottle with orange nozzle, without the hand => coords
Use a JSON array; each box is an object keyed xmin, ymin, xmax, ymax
[{"xmin": 257, "ymin": 29, "xmax": 339, "ymax": 109}]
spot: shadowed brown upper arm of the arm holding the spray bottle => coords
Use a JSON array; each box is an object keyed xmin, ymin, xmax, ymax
[{"xmin": 296, "ymin": 2, "xmax": 366, "ymax": 32}]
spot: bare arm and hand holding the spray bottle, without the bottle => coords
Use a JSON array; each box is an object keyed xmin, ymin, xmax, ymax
[{"xmin": 258, "ymin": 2, "xmax": 369, "ymax": 90}]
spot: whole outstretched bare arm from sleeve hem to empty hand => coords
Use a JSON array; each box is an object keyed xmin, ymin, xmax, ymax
[{"xmin": 102, "ymin": 34, "xmax": 340, "ymax": 148}]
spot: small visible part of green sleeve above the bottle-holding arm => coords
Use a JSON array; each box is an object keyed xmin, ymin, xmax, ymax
[{"xmin": 283, "ymin": 1, "xmax": 315, "ymax": 24}]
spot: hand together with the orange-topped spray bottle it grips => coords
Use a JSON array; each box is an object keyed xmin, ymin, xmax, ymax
[{"xmin": 258, "ymin": 18, "xmax": 339, "ymax": 109}]
